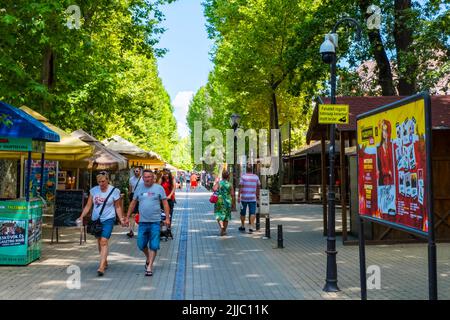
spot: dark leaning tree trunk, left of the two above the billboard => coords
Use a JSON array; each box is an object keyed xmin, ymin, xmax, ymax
[{"xmin": 359, "ymin": 0, "xmax": 396, "ymax": 96}]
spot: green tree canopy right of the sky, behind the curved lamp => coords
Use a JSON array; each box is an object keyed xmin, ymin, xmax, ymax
[{"xmin": 189, "ymin": 0, "xmax": 450, "ymax": 151}]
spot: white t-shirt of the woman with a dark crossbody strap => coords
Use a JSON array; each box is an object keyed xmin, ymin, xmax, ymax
[{"xmin": 90, "ymin": 185, "xmax": 120, "ymax": 222}]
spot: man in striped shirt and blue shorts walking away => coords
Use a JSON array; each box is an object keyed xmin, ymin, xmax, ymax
[{"xmin": 238, "ymin": 164, "xmax": 261, "ymax": 233}]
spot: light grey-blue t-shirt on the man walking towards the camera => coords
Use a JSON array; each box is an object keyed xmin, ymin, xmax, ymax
[{"xmin": 133, "ymin": 183, "xmax": 167, "ymax": 222}]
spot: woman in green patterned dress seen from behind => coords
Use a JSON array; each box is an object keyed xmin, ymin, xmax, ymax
[{"xmin": 213, "ymin": 170, "xmax": 234, "ymax": 236}]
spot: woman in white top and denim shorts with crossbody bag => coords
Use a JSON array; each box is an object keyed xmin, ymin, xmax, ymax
[{"xmin": 79, "ymin": 171, "xmax": 124, "ymax": 277}]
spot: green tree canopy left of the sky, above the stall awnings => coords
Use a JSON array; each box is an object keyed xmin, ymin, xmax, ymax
[{"xmin": 0, "ymin": 0, "xmax": 178, "ymax": 161}]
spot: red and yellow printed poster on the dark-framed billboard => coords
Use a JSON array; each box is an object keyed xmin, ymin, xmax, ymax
[{"xmin": 357, "ymin": 98, "xmax": 428, "ymax": 233}]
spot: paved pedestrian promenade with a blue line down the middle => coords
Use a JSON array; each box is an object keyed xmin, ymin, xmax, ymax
[{"xmin": 0, "ymin": 188, "xmax": 450, "ymax": 300}]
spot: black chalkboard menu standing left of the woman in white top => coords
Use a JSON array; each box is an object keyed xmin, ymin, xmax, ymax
[{"xmin": 53, "ymin": 190, "xmax": 83, "ymax": 227}]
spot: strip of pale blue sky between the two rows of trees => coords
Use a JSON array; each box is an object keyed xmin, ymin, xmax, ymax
[{"xmin": 158, "ymin": 0, "xmax": 213, "ymax": 136}]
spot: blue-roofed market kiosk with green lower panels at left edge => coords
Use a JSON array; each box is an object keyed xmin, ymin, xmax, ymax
[{"xmin": 0, "ymin": 102, "xmax": 60, "ymax": 265}]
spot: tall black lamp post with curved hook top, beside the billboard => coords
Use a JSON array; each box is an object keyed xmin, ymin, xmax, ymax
[{"xmin": 320, "ymin": 18, "xmax": 361, "ymax": 292}]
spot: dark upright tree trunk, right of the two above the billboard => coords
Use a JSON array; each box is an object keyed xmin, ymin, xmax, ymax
[{"xmin": 394, "ymin": 0, "xmax": 417, "ymax": 96}]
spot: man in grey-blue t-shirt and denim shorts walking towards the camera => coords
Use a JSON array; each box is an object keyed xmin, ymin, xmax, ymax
[{"xmin": 125, "ymin": 170, "xmax": 170, "ymax": 276}]
